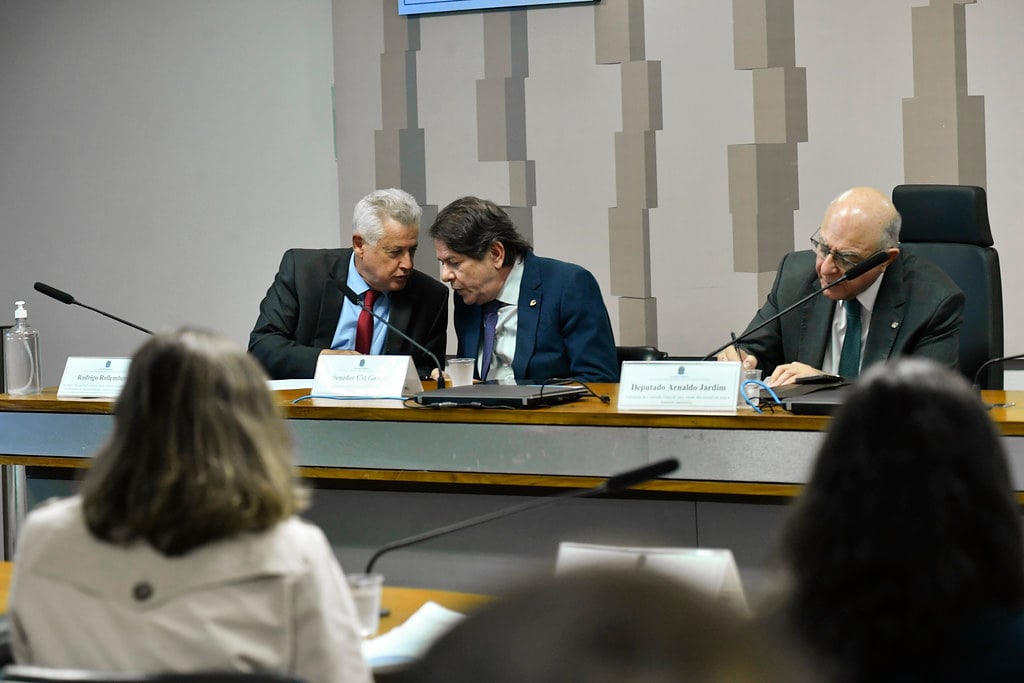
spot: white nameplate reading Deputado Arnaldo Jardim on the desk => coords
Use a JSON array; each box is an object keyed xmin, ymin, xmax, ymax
[{"xmin": 618, "ymin": 360, "xmax": 739, "ymax": 413}]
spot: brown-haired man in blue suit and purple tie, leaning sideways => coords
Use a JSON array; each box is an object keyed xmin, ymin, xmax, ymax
[{"xmin": 430, "ymin": 197, "xmax": 618, "ymax": 382}]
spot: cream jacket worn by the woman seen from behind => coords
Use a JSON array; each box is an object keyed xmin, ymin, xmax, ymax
[{"xmin": 8, "ymin": 497, "xmax": 372, "ymax": 683}]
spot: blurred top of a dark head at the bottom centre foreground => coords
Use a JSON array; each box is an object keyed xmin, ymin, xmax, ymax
[{"xmin": 396, "ymin": 569, "xmax": 817, "ymax": 683}]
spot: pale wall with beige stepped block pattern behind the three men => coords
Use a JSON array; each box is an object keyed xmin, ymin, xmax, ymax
[{"xmin": 335, "ymin": 0, "xmax": 1024, "ymax": 354}]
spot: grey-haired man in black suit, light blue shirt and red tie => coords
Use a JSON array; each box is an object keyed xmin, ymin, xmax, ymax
[{"xmin": 249, "ymin": 189, "xmax": 447, "ymax": 379}]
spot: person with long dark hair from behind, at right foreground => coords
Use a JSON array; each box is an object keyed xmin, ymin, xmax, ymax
[{"xmin": 781, "ymin": 358, "xmax": 1024, "ymax": 683}]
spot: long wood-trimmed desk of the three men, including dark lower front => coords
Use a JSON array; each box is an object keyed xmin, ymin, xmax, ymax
[{"xmin": 0, "ymin": 385, "xmax": 1024, "ymax": 581}]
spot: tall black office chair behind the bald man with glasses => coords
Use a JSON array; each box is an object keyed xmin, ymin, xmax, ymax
[{"xmin": 893, "ymin": 185, "xmax": 1002, "ymax": 389}]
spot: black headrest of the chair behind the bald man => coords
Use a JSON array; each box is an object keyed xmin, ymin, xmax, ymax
[{"xmin": 893, "ymin": 185, "xmax": 992, "ymax": 247}]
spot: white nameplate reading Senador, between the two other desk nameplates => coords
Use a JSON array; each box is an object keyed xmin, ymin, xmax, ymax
[{"xmin": 312, "ymin": 353, "xmax": 423, "ymax": 398}]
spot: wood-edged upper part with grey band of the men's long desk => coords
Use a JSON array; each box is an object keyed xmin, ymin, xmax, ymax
[{"xmin": 0, "ymin": 384, "xmax": 1024, "ymax": 497}]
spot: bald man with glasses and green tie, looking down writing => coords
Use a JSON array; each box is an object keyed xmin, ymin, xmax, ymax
[{"xmin": 718, "ymin": 187, "xmax": 964, "ymax": 386}]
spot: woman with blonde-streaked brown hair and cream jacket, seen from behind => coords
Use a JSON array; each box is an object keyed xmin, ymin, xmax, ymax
[{"xmin": 8, "ymin": 329, "xmax": 371, "ymax": 683}]
